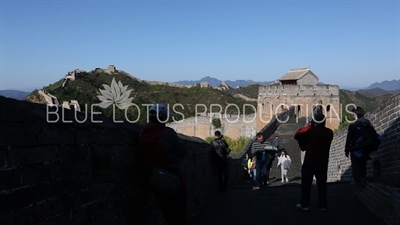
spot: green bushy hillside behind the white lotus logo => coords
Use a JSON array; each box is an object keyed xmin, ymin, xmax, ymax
[{"xmin": 27, "ymin": 71, "xmax": 255, "ymax": 123}]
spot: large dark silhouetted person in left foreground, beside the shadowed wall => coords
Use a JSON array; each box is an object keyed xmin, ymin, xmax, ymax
[{"xmin": 139, "ymin": 103, "xmax": 187, "ymax": 224}]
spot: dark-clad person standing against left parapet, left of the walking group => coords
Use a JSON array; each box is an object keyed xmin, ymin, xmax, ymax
[{"xmin": 210, "ymin": 130, "xmax": 231, "ymax": 192}]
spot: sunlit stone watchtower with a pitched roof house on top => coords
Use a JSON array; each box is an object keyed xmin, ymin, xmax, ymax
[{"xmin": 257, "ymin": 68, "xmax": 341, "ymax": 130}]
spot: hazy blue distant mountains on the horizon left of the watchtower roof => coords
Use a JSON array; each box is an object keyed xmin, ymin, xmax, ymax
[{"xmin": 173, "ymin": 76, "xmax": 274, "ymax": 88}]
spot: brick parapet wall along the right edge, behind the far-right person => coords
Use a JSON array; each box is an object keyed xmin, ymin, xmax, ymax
[{"xmin": 328, "ymin": 95, "xmax": 400, "ymax": 224}]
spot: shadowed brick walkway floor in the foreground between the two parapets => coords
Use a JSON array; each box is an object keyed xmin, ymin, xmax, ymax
[{"xmin": 190, "ymin": 181, "xmax": 386, "ymax": 225}]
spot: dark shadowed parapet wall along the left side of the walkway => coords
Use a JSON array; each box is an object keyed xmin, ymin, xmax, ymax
[{"xmin": 0, "ymin": 96, "xmax": 241, "ymax": 224}]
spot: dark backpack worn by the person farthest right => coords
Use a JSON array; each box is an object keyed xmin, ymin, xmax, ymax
[{"xmin": 353, "ymin": 122, "xmax": 383, "ymax": 154}]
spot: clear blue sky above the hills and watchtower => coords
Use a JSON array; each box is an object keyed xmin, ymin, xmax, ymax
[{"xmin": 0, "ymin": 0, "xmax": 400, "ymax": 89}]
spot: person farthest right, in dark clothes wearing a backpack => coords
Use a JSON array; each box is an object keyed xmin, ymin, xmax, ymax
[{"xmin": 345, "ymin": 106, "xmax": 380, "ymax": 185}]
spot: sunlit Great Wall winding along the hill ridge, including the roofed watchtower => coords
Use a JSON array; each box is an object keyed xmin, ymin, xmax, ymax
[{"xmin": 39, "ymin": 65, "xmax": 341, "ymax": 139}]
